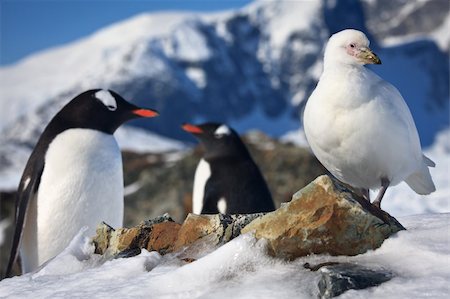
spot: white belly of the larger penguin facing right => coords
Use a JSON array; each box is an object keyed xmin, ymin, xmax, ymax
[{"xmin": 22, "ymin": 129, "xmax": 123, "ymax": 272}]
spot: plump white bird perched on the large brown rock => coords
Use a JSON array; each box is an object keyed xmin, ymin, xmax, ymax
[{"xmin": 303, "ymin": 29, "xmax": 436, "ymax": 208}]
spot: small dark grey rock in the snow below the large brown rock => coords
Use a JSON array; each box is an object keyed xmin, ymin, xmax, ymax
[{"xmin": 318, "ymin": 263, "xmax": 394, "ymax": 299}]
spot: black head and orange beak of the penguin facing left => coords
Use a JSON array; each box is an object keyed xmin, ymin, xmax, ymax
[{"xmin": 182, "ymin": 123, "xmax": 249, "ymax": 160}]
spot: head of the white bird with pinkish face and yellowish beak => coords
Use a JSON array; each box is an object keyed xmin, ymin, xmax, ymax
[{"xmin": 325, "ymin": 29, "xmax": 381, "ymax": 65}]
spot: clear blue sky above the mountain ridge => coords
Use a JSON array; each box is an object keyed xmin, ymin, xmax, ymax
[{"xmin": 0, "ymin": 0, "xmax": 252, "ymax": 66}]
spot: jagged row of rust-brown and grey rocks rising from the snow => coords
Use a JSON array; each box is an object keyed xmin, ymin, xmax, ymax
[{"xmin": 94, "ymin": 175, "xmax": 405, "ymax": 259}]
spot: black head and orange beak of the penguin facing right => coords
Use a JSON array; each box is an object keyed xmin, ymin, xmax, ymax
[{"xmin": 55, "ymin": 89, "xmax": 158, "ymax": 134}]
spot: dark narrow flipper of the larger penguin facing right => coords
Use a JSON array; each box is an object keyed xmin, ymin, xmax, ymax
[{"xmin": 5, "ymin": 156, "xmax": 44, "ymax": 277}]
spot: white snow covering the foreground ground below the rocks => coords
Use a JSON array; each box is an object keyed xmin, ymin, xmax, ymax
[{"xmin": 0, "ymin": 214, "xmax": 450, "ymax": 299}]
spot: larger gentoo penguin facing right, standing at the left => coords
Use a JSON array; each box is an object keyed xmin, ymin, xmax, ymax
[{"xmin": 6, "ymin": 89, "xmax": 158, "ymax": 276}]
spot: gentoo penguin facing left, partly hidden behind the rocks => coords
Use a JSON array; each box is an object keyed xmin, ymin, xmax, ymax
[{"xmin": 183, "ymin": 123, "xmax": 275, "ymax": 214}]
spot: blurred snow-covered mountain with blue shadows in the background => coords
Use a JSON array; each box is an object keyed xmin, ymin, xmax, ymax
[{"xmin": 0, "ymin": 0, "xmax": 450, "ymax": 190}]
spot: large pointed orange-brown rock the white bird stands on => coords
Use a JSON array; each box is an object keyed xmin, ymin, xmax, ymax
[{"xmin": 242, "ymin": 175, "xmax": 405, "ymax": 259}]
